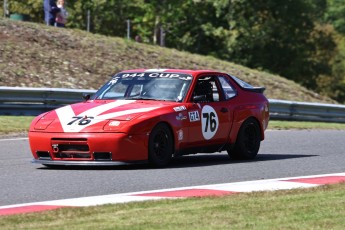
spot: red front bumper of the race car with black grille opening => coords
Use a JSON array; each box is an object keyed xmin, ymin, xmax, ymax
[{"xmin": 29, "ymin": 132, "xmax": 148, "ymax": 166}]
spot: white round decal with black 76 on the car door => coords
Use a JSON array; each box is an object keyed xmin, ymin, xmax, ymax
[{"xmin": 201, "ymin": 105, "xmax": 219, "ymax": 140}]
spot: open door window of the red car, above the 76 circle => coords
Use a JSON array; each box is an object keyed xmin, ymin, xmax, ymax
[{"xmin": 193, "ymin": 76, "xmax": 220, "ymax": 102}]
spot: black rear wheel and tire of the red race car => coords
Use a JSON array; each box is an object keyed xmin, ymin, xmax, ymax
[{"xmin": 228, "ymin": 118, "xmax": 261, "ymax": 160}]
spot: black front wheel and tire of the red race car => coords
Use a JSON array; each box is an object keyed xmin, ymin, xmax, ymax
[{"xmin": 149, "ymin": 123, "xmax": 174, "ymax": 167}]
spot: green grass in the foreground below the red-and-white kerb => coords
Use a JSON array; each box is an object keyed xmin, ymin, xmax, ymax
[{"xmin": 0, "ymin": 183, "xmax": 345, "ymax": 229}]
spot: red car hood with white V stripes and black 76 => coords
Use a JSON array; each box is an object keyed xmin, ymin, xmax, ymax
[{"xmin": 31, "ymin": 100, "xmax": 174, "ymax": 132}]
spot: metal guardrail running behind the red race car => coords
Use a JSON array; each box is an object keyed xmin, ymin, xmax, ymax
[{"xmin": 0, "ymin": 87, "xmax": 345, "ymax": 123}]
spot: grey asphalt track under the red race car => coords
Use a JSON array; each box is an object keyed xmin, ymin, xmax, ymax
[{"xmin": 0, "ymin": 130, "xmax": 345, "ymax": 206}]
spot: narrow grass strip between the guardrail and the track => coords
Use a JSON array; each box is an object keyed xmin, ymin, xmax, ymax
[{"xmin": 0, "ymin": 116, "xmax": 345, "ymax": 135}]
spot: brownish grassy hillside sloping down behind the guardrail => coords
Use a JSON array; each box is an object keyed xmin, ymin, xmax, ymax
[{"xmin": 0, "ymin": 18, "xmax": 335, "ymax": 103}]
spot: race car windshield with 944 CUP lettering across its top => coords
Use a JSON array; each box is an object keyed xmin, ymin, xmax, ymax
[{"xmin": 94, "ymin": 72, "xmax": 192, "ymax": 102}]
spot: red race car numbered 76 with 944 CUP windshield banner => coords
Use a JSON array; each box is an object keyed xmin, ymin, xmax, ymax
[{"xmin": 29, "ymin": 69, "xmax": 269, "ymax": 167}]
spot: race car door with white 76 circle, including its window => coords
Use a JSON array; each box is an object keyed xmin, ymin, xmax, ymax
[{"xmin": 188, "ymin": 75, "xmax": 233, "ymax": 147}]
